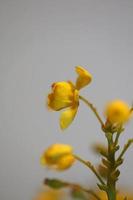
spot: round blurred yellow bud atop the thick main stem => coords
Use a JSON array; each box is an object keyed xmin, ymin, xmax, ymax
[{"xmin": 105, "ymin": 100, "xmax": 131, "ymax": 124}]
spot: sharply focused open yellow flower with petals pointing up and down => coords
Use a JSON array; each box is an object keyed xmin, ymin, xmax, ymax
[{"xmin": 47, "ymin": 66, "xmax": 92, "ymax": 129}]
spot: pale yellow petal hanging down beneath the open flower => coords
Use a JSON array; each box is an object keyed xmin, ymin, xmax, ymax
[{"xmin": 60, "ymin": 104, "xmax": 78, "ymax": 130}]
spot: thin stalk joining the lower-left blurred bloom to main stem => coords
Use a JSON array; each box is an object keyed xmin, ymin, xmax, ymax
[{"xmin": 73, "ymin": 155, "xmax": 105, "ymax": 185}]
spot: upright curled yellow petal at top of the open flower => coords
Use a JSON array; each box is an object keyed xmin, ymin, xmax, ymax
[{"xmin": 76, "ymin": 66, "xmax": 92, "ymax": 90}]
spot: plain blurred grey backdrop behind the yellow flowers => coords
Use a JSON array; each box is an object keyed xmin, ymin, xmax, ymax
[{"xmin": 0, "ymin": 0, "xmax": 133, "ymax": 200}]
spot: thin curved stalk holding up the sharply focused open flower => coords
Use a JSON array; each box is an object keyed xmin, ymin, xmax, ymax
[{"xmin": 79, "ymin": 96, "xmax": 104, "ymax": 127}]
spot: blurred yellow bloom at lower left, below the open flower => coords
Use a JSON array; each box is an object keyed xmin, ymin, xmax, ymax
[{"xmin": 41, "ymin": 144, "xmax": 75, "ymax": 170}]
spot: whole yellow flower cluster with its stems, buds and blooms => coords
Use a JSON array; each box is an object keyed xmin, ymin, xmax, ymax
[{"xmin": 41, "ymin": 66, "xmax": 133, "ymax": 200}]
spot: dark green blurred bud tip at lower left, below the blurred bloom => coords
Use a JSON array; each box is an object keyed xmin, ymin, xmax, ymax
[{"xmin": 44, "ymin": 178, "xmax": 68, "ymax": 189}]
